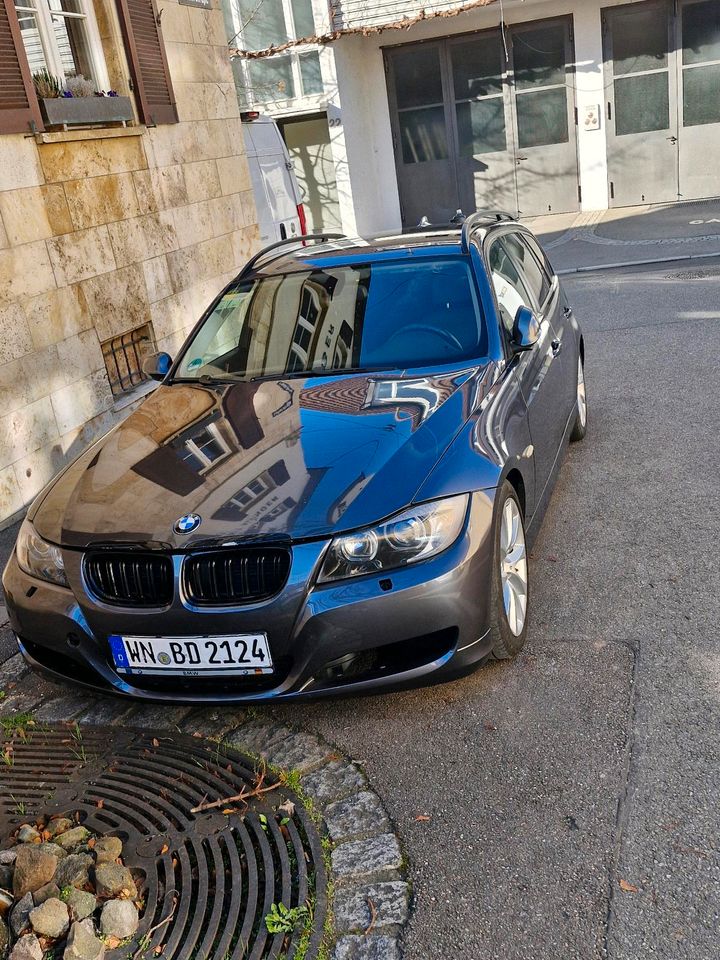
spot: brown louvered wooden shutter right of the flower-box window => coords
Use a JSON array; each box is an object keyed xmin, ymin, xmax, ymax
[{"xmin": 116, "ymin": 0, "xmax": 178, "ymax": 125}]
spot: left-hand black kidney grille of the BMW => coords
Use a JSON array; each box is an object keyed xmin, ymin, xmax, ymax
[{"xmin": 85, "ymin": 551, "xmax": 174, "ymax": 607}]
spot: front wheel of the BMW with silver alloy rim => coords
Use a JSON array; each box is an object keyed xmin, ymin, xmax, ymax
[{"xmin": 489, "ymin": 481, "xmax": 530, "ymax": 660}]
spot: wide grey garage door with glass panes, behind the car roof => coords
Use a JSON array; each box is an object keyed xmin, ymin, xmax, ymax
[{"xmin": 385, "ymin": 18, "xmax": 578, "ymax": 225}]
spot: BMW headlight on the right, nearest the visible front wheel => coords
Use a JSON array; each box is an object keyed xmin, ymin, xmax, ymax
[{"xmin": 318, "ymin": 493, "xmax": 469, "ymax": 583}]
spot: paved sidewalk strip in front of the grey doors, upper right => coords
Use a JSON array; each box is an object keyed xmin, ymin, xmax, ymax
[{"xmin": 524, "ymin": 199, "xmax": 720, "ymax": 273}]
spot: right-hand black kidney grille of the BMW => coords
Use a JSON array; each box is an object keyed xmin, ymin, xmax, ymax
[{"xmin": 183, "ymin": 548, "xmax": 290, "ymax": 605}]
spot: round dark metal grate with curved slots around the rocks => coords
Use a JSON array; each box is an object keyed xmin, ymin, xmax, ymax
[{"xmin": 0, "ymin": 726, "xmax": 327, "ymax": 960}]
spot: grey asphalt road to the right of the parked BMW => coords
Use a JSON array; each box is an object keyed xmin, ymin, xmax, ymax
[{"xmin": 0, "ymin": 261, "xmax": 720, "ymax": 960}]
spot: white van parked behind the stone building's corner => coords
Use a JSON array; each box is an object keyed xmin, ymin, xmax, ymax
[{"xmin": 241, "ymin": 110, "xmax": 307, "ymax": 245}]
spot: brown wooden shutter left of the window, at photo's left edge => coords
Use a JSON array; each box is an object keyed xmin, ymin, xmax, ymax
[{"xmin": 0, "ymin": 0, "xmax": 43, "ymax": 133}]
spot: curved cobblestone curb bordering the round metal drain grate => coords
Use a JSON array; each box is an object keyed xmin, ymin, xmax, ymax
[{"xmin": 0, "ymin": 654, "xmax": 410, "ymax": 960}]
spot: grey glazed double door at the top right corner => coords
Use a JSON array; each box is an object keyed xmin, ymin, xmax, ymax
[{"xmin": 603, "ymin": 0, "xmax": 720, "ymax": 206}]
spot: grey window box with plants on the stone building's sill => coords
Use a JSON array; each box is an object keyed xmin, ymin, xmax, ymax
[{"xmin": 33, "ymin": 70, "xmax": 134, "ymax": 128}]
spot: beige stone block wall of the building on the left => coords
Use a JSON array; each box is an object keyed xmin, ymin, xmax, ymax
[{"xmin": 0, "ymin": 0, "xmax": 258, "ymax": 523}]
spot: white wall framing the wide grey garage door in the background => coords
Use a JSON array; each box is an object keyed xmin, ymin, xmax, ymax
[{"xmin": 330, "ymin": 0, "xmax": 648, "ymax": 234}]
